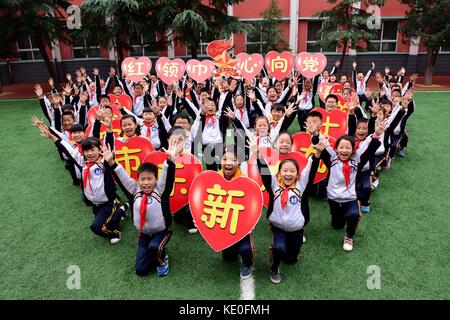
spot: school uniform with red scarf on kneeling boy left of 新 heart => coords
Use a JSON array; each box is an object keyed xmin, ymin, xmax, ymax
[{"xmin": 111, "ymin": 160, "xmax": 175, "ymax": 276}]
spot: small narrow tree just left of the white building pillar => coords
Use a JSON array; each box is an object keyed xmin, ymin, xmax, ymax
[{"xmin": 259, "ymin": 0, "xmax": 289, "ymax": 51}]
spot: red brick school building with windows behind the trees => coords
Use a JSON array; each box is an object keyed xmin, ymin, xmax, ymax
[{"xmin": 0, "ymin": 0, "xmax": 450, "ymax": 83}]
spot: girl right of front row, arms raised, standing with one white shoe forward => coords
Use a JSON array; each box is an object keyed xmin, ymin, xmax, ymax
[{"xmin": 314, "ymin": 124, "xmax": 384, "ymax": 251}]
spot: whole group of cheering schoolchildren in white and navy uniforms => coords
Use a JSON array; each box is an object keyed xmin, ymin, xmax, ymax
[{"xmin": 32, "ymin": 63, "xmax": 417, "ymax": 283}]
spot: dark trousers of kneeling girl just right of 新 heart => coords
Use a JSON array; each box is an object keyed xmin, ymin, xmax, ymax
[{"xmin": 270, "ymin": 225, "xmax": 303, "ymax": 272}]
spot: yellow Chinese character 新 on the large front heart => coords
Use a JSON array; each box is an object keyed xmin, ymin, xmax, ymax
[{"xmin": 201, "ymin": 184, "xmax": 245, "ymax": 234}]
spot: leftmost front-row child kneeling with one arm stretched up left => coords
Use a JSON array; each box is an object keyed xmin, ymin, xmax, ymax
[{"xmin": 39, "ymin": 126, "xmax": 129, "ymax": 244}]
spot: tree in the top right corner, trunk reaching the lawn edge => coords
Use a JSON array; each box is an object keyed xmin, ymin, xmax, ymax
[{"xmin": 401, "ymin": 0, "xmax": 450, "ymax": 85}]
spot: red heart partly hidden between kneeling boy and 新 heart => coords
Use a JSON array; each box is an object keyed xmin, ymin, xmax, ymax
[{"xmin": 143, "ymin": 151, "xmax": 203, "ymax": 214}]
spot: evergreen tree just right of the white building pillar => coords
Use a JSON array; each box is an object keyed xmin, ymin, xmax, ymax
[{"xmin": 315, "ymin": 0, "xmax": 384, "ymax": 66}]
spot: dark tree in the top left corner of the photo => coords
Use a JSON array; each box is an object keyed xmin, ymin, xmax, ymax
[{"xmin": 0, "ymin": 0, "xmax": 70, "ymax": 83}]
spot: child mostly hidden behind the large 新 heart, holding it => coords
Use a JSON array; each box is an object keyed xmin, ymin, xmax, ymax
[{"xmin": 219, "ymin": 145, "xmax": 254, "ymax": 280}]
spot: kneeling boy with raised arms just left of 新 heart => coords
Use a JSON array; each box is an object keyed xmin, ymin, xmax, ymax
[{"xmin": 103, "ymin": 140, "xmax": 180, "ymax": 276}]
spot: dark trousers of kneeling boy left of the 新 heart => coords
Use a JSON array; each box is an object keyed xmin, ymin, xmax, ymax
[{"xmin": 135, "ymin": 230, "xmax": 172, "ymax": 276}]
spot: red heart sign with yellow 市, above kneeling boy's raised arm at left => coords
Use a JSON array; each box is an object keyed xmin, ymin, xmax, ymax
[{"xmin": 114, "ymin": 137, "xmax": 155, "ymax": 179}]
